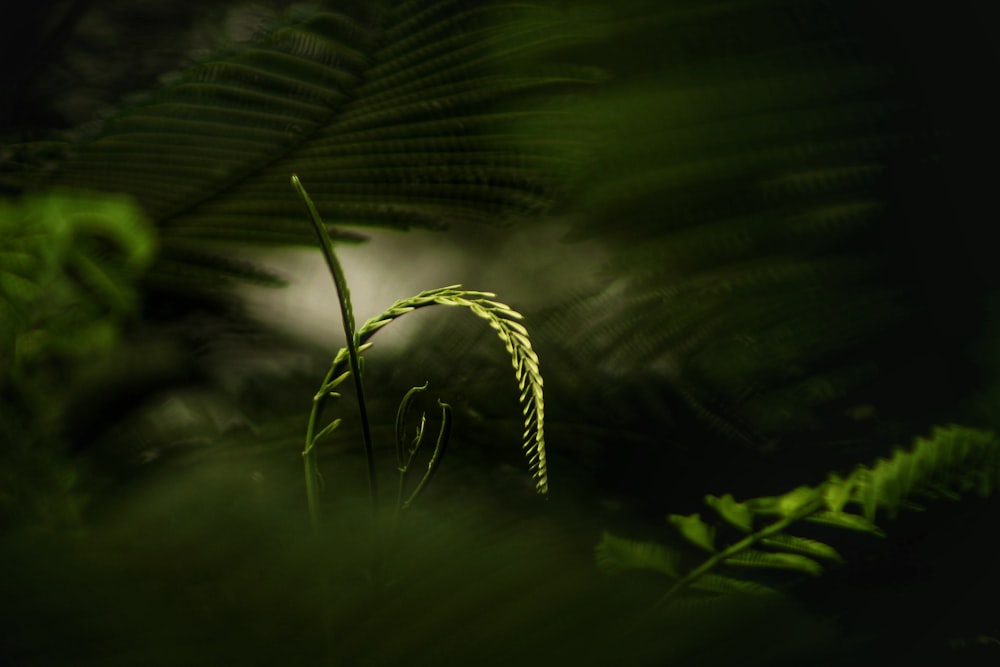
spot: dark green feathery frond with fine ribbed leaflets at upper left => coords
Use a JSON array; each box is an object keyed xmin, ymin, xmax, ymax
[{"xmin": 11, "ymin": 0, "xmax": 598, "ymax": 290}]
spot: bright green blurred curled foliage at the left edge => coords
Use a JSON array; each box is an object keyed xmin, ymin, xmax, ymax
[{"xmin": 0, "ymin": 192, "xmax": 156, "ymax": 400}]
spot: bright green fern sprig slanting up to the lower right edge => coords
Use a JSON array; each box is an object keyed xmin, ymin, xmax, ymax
[{"xmin": 597, "ymin": 426, "xmax": 1000, "ymax": 600}]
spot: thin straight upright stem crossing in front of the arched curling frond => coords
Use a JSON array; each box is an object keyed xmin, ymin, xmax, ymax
[{"xmin": 292, "ymin": 174, "xmax": 378, "ymax": 509}]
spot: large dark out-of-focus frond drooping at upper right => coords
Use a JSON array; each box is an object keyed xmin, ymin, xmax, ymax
[{"xmin": 539, "ymin": 0, "xmax": 964, "ymax": 450}]
